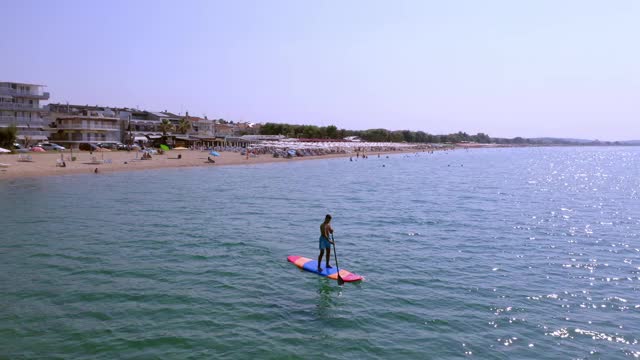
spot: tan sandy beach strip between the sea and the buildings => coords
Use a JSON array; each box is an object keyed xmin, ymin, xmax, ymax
[{"xmin": 0, "ymin": 148, "xmax": 424, "ymax": 180}]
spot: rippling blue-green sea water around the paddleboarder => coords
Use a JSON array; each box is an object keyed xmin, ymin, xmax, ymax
[{"xmin": 0, "ymin": 148, "xmax": 640, "ymax": 359}]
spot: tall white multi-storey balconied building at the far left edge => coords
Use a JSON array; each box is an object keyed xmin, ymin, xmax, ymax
[{"xmin": 0, "ymin": 82, "xmax": 49, "ymax": 143}]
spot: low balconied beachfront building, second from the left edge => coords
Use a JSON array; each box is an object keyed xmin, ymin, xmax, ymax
[{"xmin": 49, "ymin": 104, "xmax": 124, "ymax": 148}]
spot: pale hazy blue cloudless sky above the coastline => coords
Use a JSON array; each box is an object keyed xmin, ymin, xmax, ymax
[{"xmin": 5, "ymin": 0, "xmax": 640, "ymax": 140}]
